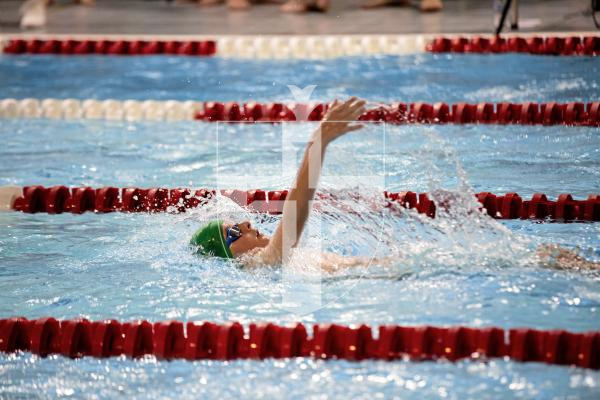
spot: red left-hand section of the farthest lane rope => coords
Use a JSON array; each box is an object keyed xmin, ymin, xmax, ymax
[{"xmin": 3, "ymin": 39, "xmax": 217, "ymax": 56}]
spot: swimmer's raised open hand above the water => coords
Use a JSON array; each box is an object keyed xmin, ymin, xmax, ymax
[{"xmin": 314, "ymin": 97, "xmax": 366, "ymax": 146}]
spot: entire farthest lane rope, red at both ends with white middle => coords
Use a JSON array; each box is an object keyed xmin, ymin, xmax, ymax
[{"xmin": 0, "ymin": 32, "xmax": 600, "ymax": 59}]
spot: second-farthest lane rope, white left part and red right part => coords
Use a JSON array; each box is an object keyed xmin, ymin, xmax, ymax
[{"xmin": 0, "ymin": 98, "xmax": 600, "ymax": 126}]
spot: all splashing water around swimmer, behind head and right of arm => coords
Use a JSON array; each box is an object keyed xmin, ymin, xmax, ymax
[{"xmin": 165, "ymin": 128, "xmax": 535, "ymax": 282}]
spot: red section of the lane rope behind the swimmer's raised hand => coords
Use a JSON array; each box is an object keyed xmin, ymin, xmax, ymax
[{"xmin": 188, "ymin": 102, "xmax": 600, "ymax": 126}]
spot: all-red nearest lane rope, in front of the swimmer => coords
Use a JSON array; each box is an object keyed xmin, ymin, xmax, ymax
[{"xmin": 0, "ymin": 317, "xmax": 600, "ymax": 369}]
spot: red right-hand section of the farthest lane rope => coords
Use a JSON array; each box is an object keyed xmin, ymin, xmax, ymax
[{"xmin": 426, "ymin": 36, "xmax": 600, "ymax": 56}]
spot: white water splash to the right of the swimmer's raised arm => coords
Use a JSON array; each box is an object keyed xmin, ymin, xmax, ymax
[{"xmin": 315, "ymin": 128, "xmax": 535, "ymax": 275}]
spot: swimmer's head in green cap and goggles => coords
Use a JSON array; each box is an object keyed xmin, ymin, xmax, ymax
[{"xmin": 190, "ymin": 220, "xmax": 269, "ymax": 258}]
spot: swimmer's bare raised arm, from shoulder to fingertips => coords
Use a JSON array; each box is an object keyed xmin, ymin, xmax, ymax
[{"xmin": 262, "ymin": 97, "xmax": 365, "ymax": 264}]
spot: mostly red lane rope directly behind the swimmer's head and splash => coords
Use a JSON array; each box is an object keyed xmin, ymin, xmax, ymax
[{"xmin": 0, "ymin": 186, "xmax": 600, "ymax": 221}]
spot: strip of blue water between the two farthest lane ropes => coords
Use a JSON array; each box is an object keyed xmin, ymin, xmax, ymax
[{"xmin": 0, "ymin": 54, "xmax": 600, "ymax": 102}]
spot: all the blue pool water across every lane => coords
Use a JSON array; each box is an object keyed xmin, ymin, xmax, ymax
[{"xmin": 0, "ymin": 55, "xmax": 600, "ymax": 398}]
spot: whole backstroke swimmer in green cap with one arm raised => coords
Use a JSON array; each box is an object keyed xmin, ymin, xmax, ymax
[{"xmin": 191, "ymin": 97, "xmax": 600, "ymax": 272}]
